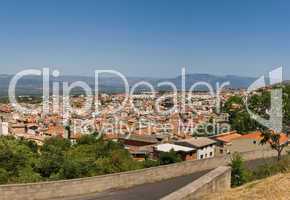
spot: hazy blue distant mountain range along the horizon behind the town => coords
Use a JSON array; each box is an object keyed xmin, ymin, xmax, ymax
[{"xmin": 0, "ymin": 74, "xmax": 262, "ymax": 96}]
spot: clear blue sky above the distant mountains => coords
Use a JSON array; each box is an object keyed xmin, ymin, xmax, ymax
[{"xmin": 0, "ymin": 0, "xmax": 290, "ymax": 79}]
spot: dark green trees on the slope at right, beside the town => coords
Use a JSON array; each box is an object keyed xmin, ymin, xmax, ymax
[{"xmin": 223, "ymin": 84, "xmax": 290, "ymax": 160}]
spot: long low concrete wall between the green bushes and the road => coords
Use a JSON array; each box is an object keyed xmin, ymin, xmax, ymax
[{"xmin": 0, "ymin": 151, "xmax": 276, "ymax": 200}]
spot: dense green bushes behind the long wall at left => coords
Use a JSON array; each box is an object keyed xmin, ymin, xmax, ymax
[{"xmin": 0, "ymin": 134, "xmax": 181, "ymax": 184}]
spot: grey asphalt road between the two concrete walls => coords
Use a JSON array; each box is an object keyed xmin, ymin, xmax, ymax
[{"xmin": 59, "ymin": 171, "xmax": 209, "ymax": 200}]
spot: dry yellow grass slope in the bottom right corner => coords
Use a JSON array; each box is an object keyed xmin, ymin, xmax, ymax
[{"xmin": 203, "ymin": 173, "xmax": 290, "ymax": 200}]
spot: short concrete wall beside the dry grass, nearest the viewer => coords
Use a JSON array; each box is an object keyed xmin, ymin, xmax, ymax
[{"xmin": 161, "ymin": 166, "xmax": 231, "ymax": 200}]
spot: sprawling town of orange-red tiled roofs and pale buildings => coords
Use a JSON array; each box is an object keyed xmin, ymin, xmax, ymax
[{"xmin": 0, "ymin": 89, "xmax": 288, "ymax": 164}]
